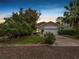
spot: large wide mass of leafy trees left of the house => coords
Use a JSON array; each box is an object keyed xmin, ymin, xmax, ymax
[{"xmin": 2, "ymin": 8, "xmax": 40, "ymax": 37}]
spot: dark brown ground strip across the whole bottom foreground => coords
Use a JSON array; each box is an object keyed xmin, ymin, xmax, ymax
[{"xmin": 0, "ymin": 46, "xmax": 79, "ymax": 59}]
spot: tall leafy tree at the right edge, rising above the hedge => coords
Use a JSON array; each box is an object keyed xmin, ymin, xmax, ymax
[{"xmin": 63, "ymin": 0, "xmax": 79, "ymax": 30}]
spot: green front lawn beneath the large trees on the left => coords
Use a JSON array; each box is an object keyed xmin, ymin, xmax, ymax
[{"xmin": 5, "ymin": 35, "xmax": 43, "ymax": 44}]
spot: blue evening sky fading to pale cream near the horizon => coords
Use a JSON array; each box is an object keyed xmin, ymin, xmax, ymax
[{"xmin": 0, "ymin": 0, "xmax": 70, "ymax": 22}]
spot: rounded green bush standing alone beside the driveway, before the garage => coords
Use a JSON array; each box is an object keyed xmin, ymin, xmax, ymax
[{"xmin": 44, "ymin": 33, "xmax": 56, "ymax": 44}]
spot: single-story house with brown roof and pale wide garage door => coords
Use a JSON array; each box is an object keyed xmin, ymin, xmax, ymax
[{"xmin": 37, "ymin": 22, "xmax": 58, "ymax": 35}]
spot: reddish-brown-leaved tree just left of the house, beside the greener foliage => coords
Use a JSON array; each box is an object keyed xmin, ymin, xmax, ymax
[{"xmin": 24, "ymin": 8, "xmax": 40, "ymax": 30}]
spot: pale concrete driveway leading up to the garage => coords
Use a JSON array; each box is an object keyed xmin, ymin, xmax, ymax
[{"xmin": 54, "ymin": 35, "xmax": 79, "ymax": 46}]
